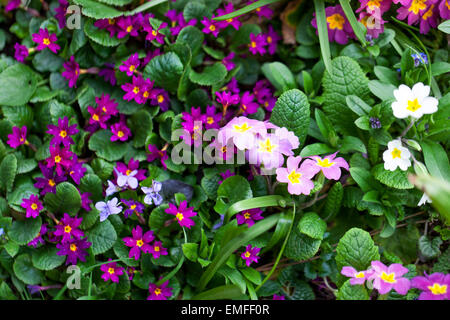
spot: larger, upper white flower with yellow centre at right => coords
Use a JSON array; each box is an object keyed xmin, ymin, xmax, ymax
[{"xmin": 391, "ymin": 82, "xmax": 439, "ymax": 119}]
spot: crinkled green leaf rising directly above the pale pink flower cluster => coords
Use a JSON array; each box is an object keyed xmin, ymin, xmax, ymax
[{"xmin": 270, "ymin": 89, "xmax": 310, "ymax": 145}]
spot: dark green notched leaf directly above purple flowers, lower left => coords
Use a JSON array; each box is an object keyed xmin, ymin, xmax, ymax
[{"xmin": 44, "ymin": 182, "xmax": 81, "ymax": 215}]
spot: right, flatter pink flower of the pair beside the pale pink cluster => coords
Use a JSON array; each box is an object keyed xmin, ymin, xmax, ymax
[{"xmin": 304, "ymin": 152, "xmax": 349, "ymax": 180}]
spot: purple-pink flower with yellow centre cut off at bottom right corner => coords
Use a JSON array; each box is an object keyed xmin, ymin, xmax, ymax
[{"xmin": 411, "ymin": 272, "xmax": 450, "ymax": 300}]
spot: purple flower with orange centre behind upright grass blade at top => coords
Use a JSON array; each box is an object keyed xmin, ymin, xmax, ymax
[{"xmin": 311, "ymin": 5, "xmax": 355, "ymax": 44}]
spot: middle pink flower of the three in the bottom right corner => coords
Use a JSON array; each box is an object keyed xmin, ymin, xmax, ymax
[{"xmin": 368, "ymin": 261, "xmax": 410, "ymax": 295}]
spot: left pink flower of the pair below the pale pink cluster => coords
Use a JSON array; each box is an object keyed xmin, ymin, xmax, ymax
[{"xmin": 276, "ymin": 156, "xmax": 316, "ymax": 195}]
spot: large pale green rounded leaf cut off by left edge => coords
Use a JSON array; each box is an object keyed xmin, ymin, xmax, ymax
[{"xmin": 0, "ymin": 63, "xmax": 36, "ymax": 106}]
